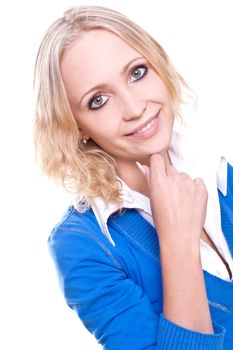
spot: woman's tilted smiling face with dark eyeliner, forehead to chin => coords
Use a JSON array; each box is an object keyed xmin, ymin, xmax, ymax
[{"xmin": 61, "ymin": 30, "xmax": 174, "ymax": 162}]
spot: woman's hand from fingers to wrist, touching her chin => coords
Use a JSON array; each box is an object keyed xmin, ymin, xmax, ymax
[{"xmin": 146, "ymin": 154, "xmax": 208, "ymax": 248}]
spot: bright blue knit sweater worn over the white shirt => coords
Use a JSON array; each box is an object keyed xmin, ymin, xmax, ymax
[{"xmin": 49, "ymin": 165, "xmax": 233, "ymax": 350}]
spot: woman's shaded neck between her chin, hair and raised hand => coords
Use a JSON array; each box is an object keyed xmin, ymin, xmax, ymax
[{"xmin": 118, "ymin": 151, "xmax": 171, "ymax": 197}]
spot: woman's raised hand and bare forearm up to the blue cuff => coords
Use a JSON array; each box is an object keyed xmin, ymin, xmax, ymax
[{"xmin": 144, "ymin": 154, "xmax": 213, "ymax": 334}]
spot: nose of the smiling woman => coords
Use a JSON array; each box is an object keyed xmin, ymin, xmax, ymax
[{"xmin": 122, "ymin": 89, "xmax": 146, "ymax": 121}]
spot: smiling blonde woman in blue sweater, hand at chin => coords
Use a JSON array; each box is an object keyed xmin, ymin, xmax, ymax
[{"xmin": 35, "ymin": 6, "xmax": 233, "ymax": 350}]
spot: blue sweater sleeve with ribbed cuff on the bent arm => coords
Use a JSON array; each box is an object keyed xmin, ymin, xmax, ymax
[{"xmin": 49, "ymin": 226, "xmax": 224, "ymax": 350}]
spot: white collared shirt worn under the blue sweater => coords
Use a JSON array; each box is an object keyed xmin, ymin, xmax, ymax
[{"xmin": 75, "ymin": 132, "xmax": 233, "ymax": 281}]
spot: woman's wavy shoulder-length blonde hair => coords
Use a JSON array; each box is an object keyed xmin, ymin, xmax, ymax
[{"xmin": 34, "ymin": 6, "xmax": 187, "ymax": 208}]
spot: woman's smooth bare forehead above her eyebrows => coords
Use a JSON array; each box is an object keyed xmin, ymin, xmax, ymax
[{"xmin": 61, "ymin": 30, "xmax": 140, "ymax": 101}]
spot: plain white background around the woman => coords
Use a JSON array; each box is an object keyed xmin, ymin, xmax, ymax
[{"xmin": 0, "ymin": 0, "xmax": 233, "ymax": 350}]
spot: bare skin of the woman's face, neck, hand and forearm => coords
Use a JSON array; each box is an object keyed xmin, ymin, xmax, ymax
[{"xmin": 61, "ymin": 30, "xmax": 213, "ymax": 333}]
